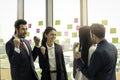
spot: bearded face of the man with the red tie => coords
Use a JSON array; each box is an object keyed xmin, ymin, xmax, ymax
[{"xmin": 16, "ymin": 24, "xmax": 27, "ymax": 38}]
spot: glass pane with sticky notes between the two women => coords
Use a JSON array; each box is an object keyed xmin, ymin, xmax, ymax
[{"xmin": 53, "ymin": 0, "xmax": 80, "ymax": 80}]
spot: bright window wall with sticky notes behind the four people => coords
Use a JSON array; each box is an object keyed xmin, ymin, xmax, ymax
[{"xmin": 0, "ymin": 0, "xmax": 120, "ymax": 80}]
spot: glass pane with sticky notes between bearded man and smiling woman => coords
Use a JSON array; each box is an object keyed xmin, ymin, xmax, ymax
[{"xmin": 24, "ymin": 0, "xmax": 46, "ymax": 78}]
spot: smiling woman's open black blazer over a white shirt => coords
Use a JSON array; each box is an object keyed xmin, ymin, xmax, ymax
[{"xmin": 33, "ymin": 43, "xmax": 68, "ymax": 80}]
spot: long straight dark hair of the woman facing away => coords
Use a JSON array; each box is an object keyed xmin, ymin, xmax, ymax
[{"xmin": 79, "ymin": 26, "xmax": 92, "ymax": 66}]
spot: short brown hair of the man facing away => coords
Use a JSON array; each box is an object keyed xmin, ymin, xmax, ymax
[{"xmin": 90, "ymin": 23, "xmax": 105, "ymax": 39}]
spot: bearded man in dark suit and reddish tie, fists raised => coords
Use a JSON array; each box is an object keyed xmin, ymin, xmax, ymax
[{"xmin": 6, "ymin": 19, "xmax": 39, "ymax": 80}]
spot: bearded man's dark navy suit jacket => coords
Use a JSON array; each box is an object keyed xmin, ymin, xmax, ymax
[{"xmin": 6, "ymin": 37, "xmax": 39, "ymax": 80}]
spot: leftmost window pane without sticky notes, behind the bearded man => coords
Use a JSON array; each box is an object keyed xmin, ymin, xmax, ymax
[{"xmin": 0, "ymin": 0, "xmax": 17, "ymax": 80}]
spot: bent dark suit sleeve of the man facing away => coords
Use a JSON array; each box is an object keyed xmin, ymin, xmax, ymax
[{"xmin": 77, "ymin": 51, "xmax": 104, "ymax": 78}]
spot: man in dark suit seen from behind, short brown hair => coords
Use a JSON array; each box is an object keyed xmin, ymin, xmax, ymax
[{"xmin": 74, "ymin": 23, "xmax": 117, "ymax": 80}]
